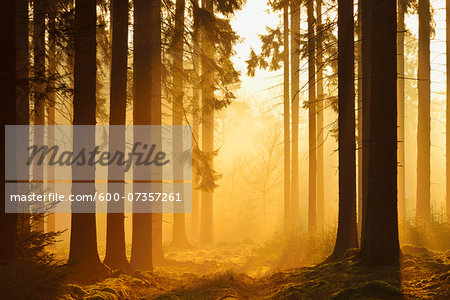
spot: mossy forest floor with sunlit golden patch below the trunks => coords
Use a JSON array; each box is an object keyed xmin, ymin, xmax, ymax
[{"xmin": 64, "ymin": 242, "xmax": 450, "ymax": 300}]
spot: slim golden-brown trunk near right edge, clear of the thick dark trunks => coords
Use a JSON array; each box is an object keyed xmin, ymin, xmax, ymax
[{"xmin": 416, "ymin": 0, "xmax": 431, "ymax": 223}]
